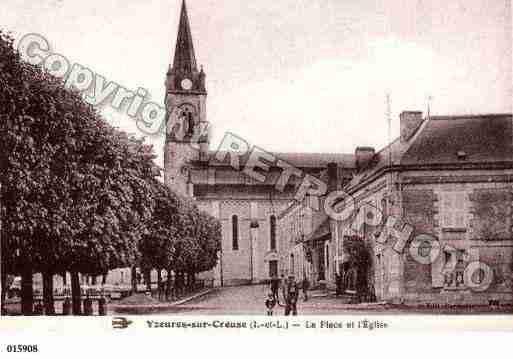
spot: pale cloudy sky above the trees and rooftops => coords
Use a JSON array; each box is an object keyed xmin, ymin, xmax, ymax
[{"xmin": 0, "ymin": 0, "xmax": 513, "ymax": 169}]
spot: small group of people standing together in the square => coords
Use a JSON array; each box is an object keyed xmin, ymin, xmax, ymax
[{"xmin": 265, "ymin": 274, "xmax": 310, "ymax": 315}]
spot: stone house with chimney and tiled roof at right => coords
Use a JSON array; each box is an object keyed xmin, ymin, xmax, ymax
[{"xmin": 281, "ymin": 112, "xmax": 513, "ymax": 304}]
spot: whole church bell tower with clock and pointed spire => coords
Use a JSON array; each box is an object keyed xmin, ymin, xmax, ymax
[{"xmin": 164, "ymin": 0, "xmax": 210, "ymax": 196}]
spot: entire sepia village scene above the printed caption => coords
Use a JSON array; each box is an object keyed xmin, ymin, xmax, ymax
[{"xmin": 0, "ymin": 0, "xmax": 513, "ymax": 330}]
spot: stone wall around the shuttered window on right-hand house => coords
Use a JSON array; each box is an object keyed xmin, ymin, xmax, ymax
[{"xmin": 403, "ymin": 176, "xmax": 513, "ymax": 305}]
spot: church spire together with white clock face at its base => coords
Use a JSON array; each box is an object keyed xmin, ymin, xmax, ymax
[{"xmin": 167, "ymin": 0, "xmax": 206, "ymax": 93}]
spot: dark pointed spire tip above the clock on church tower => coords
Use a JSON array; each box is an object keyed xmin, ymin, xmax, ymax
[{"xmin": 173, "ymin": 0, "xmax": 198, "ymax": 74}]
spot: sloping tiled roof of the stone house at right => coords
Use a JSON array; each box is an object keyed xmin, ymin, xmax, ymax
[{"xmin": 349, "ymin": 114, "xmax": 513, "ymax": 191}]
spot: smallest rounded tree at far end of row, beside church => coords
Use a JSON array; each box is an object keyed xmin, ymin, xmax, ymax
[{"xmin": 139, "ymin": 181, "xmax": 221, "ymax": 297}]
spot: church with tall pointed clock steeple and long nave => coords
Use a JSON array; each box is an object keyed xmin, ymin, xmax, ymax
[{"xmin": 164, "ymin": 1, "xmax": 355, "ymax": 285}]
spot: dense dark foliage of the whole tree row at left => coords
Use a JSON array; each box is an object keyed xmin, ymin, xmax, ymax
[{"xmin": 0, "ymin": 31, "xmax": 221, "ymax": 312}]
